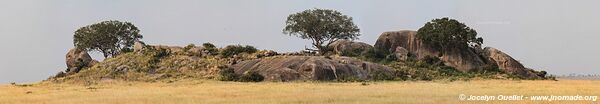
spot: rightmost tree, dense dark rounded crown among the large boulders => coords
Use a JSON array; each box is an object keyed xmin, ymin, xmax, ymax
[{"xmin": 417, "ymin": 17, "xmax": 483, "ymax": 52}]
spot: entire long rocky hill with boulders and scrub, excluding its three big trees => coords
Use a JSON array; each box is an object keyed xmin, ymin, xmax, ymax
[{"xmin": 48, "ymin": 30, "xmax": 546, "ymax": 83}]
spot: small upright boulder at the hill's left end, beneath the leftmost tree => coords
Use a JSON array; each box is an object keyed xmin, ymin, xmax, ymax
[{"xmin": 66, "ymin": 48, "xmax": 97, "ymax": 73}]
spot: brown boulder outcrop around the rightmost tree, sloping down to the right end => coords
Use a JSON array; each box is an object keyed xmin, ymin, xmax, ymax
[{"xmin": 375, "ymin": 30, "xmax": 544, "ymax": 79}]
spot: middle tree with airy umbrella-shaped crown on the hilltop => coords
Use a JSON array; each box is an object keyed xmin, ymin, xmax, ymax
[{"xmin": 283, "ymin": 8, "xmax": 360, "ymax": 54}]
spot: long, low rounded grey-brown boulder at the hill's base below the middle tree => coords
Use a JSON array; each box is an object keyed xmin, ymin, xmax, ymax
[{"xmin": 232, "ymin": 56, "xmax": 392, "ymax": 81}]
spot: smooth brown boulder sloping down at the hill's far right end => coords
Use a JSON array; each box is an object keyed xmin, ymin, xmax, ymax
[{"xmin": 483, "ymin": 47, "xmax": 543, "ymax": 79}]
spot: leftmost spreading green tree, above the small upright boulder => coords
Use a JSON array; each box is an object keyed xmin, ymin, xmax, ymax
[{"xmin": 73, "ymin": 20, "xmax": 143, "ymax": 58}]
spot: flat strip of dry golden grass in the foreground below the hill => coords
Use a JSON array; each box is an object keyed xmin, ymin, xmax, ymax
[{"xmin": 0, "ymin": 80, "xmax": 600, "ymax": 104}]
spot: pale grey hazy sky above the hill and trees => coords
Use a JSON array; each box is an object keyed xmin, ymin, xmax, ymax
[{"xmin": 0, "ymin": 0, "xmax": 600, "ymax": 83}]
